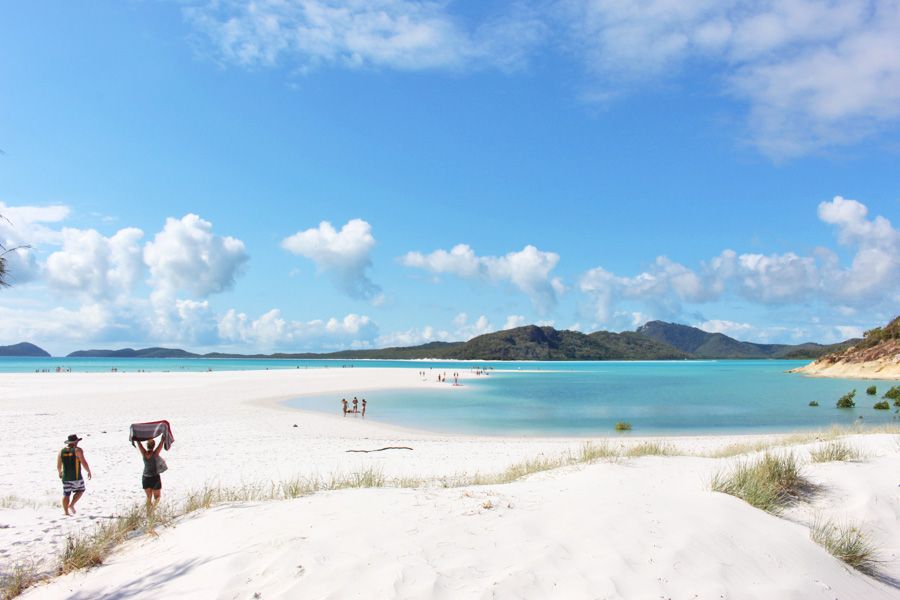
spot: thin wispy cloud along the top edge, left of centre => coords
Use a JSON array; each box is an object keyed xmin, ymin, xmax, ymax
[{"xmin": 185, "ymin": 0, "xmax": 543, "ymax": 71}]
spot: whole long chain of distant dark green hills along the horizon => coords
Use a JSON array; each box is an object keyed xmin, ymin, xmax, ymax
[{"xmin": 69, "ymin": 321, "xmax": 852, "ymax": 361}]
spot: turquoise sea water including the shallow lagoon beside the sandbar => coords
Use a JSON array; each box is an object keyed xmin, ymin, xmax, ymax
[{"xmin": 0, "ymin": 357, "xmax": 900, "ymax": 436}]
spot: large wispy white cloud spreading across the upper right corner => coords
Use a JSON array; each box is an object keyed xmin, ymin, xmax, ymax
[{"xmin": 562, "ymin": 0, "xmax": 900, "ymax": 157}]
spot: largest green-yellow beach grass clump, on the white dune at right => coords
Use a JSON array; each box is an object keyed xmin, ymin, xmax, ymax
[{"xmin": 710, "ymin": 452, "xmax": 811, "ymax": 514}]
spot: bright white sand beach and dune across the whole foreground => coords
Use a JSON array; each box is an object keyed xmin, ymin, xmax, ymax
[{"xmin": 0, "ymin": 369, "xmax": 900, "ymax": 599}]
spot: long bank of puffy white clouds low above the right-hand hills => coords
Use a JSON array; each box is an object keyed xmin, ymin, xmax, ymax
[{"xmin": 578, "ymin": 196, "xmax": 900, "ymax": 323}]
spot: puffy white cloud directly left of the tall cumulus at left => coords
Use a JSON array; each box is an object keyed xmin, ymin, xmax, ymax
[{"xmin": 45, "ymin": 227, "xmax": 144, "ymax": 299}]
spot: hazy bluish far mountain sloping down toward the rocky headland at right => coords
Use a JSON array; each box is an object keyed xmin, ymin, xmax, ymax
[{"xmin": 637, "ymin": 321, "xmax": 855, "ymax": 358}]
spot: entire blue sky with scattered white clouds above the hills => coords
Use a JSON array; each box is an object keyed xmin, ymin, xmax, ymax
[{"xmin": 0, "ymin": 0, "xmax": 900, "ymax": 355}]
